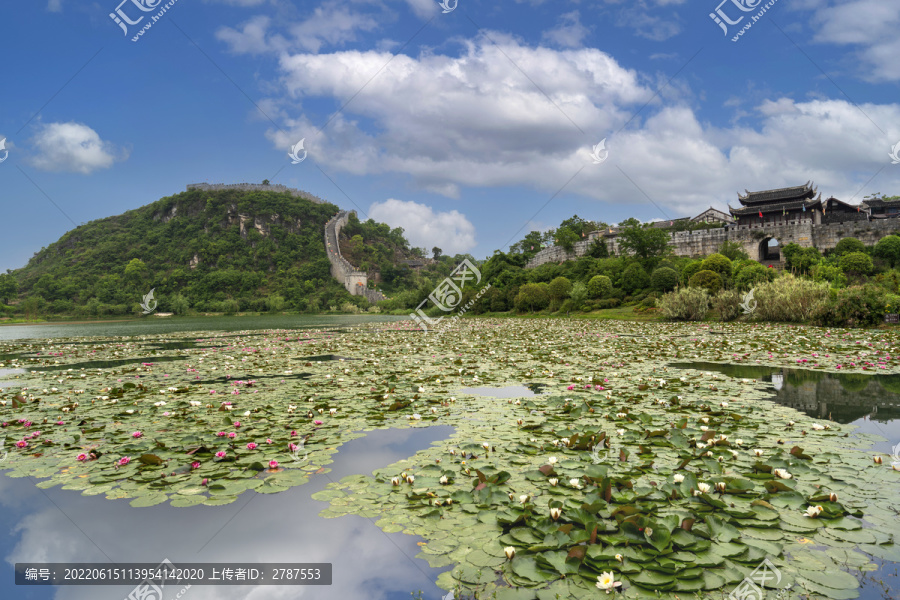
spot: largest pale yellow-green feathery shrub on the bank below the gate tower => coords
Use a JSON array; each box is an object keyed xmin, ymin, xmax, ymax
[{"xmin": 753, "ymin": 274, "xmax": 828, "ymax": 323}]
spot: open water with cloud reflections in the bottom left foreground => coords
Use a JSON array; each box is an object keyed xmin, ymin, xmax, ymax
[{"xmin": 0, "ymin": 427, "xmax": 452, "ymax": 600}]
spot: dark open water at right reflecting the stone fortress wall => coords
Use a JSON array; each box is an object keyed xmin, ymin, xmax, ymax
[{"xmin": 669, "ymin": 362, "xmax": 900, "ymax": 454}]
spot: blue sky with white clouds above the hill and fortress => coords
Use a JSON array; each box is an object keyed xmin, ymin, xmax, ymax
[{"xmin": 0, "ymin": 0, "xmax": 900, "ymax": 270}]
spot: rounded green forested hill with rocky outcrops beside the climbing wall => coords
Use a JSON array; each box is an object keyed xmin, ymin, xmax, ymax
[{"xmin": 0, "ymin": 189, "xmax": 413, "ymax": 316}]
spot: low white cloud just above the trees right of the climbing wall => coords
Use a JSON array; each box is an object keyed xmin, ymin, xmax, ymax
[{"xmin": 369, "ymin": 198, "xmax": 475, "ymax": 254}]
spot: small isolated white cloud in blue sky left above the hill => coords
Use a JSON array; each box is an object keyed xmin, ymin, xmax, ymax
[{"xmin": 30, "ymin": 121, "xmax": 128, "ymax": 175}]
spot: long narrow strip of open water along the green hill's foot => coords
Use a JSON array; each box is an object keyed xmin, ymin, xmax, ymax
[{"xmin": 0, "ymin": 314, "xmax": 409, "ymax": 343}]
